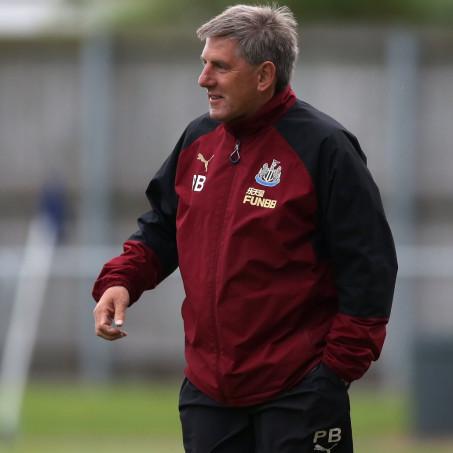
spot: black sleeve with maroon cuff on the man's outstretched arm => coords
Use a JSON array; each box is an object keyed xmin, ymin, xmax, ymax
[{"xmin": 92, "ymin": 135, "xmax": 184, "ymax": 303}]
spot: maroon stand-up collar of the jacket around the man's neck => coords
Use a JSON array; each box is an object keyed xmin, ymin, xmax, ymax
[{"xmin": 225, "ymin": 85, "xmax": 296, "ymax": 138}]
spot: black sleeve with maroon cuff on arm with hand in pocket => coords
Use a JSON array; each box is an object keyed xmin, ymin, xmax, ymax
[{"xmin": 320, "ymin": 131, "xmax": 397, "ymax": 381}]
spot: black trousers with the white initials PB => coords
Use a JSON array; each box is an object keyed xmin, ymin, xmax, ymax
[{"xmin": 179, "ymin": 365, "xmax": 353, "ymax": 453}]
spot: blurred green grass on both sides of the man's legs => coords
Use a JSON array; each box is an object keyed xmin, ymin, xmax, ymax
[{"xmin": 0, "ymin": 383, "xmax": 453, "ymax": 453}]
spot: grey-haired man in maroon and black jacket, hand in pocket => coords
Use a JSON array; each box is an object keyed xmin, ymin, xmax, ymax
[{"xmin": 93, "ymin": 5, "xmax": 397, "ymax": 453}]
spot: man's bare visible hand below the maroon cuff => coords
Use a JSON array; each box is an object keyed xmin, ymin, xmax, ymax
[{"xmin": 93, "ymin": 286, "xmax": 130, "ymax": 341}]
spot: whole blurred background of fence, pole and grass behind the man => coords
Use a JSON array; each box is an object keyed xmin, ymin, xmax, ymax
[{"xmin": 0, "ymin": 0, "xmax": 453, "ymax": 453}]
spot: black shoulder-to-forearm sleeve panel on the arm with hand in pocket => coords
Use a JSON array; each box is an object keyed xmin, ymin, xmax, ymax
[{"xmin": 276, "ymin": 100, "xmax": 397, "ymax": 318}]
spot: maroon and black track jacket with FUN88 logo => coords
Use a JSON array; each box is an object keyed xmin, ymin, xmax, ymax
[{"xmin": 93, "ymin": 87, "xmax": 397, "ymax": 406}]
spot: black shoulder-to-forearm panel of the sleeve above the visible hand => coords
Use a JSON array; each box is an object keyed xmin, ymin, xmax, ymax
[{"xmin": 129, "ymin": 115, "xmax": 217, "ymax": 278}]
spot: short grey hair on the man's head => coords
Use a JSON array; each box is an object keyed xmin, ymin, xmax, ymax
[{"xmin": 197, "ymin": 5, "xmax": 299, "ymax": 91}]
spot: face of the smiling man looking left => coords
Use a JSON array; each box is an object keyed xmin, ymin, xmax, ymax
[{"xmin": 198, "ymin": 38, "xmax": 262, "ymax": 122}]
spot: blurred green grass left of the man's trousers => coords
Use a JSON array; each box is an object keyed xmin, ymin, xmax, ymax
[{"xmin": 0, "ymin": 383, "xmax": 182, "ymax": 453}]
